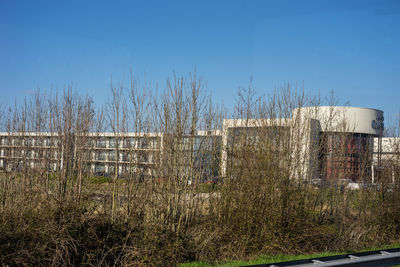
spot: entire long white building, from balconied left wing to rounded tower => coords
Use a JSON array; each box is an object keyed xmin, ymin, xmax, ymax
[{"xmin": 0, "ymin": 106, "xmax": 390, "ymax": 182}]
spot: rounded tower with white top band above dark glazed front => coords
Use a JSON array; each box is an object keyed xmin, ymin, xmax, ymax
[{"xmin": 293, "ymin": 106, "xmax": 384, "ymax": 182}]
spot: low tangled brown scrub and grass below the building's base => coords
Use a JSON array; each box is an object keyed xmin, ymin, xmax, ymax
[{"xmin": 0, "ymin": 172, "xmax": 400, "ymax": 266}]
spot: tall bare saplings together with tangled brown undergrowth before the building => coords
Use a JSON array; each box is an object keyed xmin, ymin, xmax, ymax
[{"xmin": 0, "ymin": 74, "xmax": 400, "ymax": 266}]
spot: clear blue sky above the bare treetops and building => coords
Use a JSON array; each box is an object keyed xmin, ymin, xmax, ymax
[{"xmin": 0, "ymin": 0, "xmax": 400, "ymax": 123}]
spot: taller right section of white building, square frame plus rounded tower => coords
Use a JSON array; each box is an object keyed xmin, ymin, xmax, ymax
[{"xmin": 221, "ymin": 106, "xmax": 384, "ymax": 182}]
